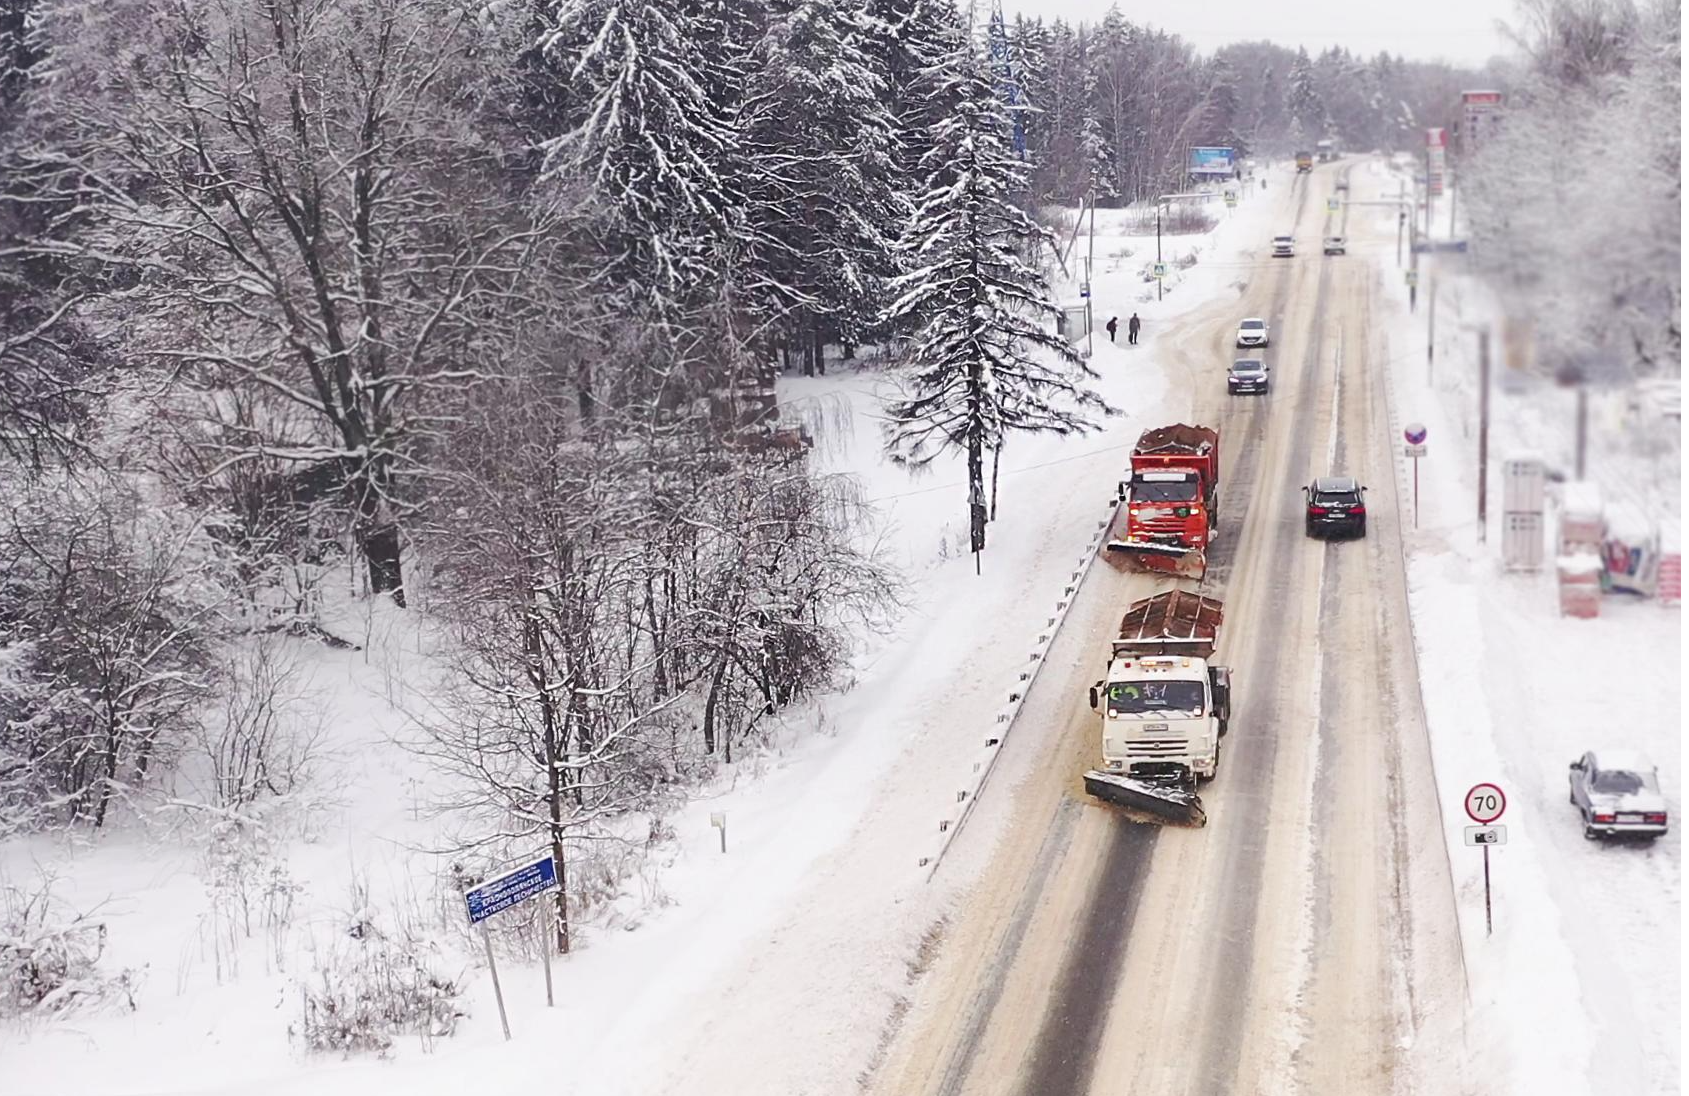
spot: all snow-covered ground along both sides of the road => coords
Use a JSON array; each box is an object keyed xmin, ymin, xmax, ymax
[{"xmin": 0, "ymin": 151, "xmax": 1661, "ymax": 1096}]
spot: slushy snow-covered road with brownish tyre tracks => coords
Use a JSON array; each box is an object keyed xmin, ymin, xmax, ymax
[{"xmin": 875, "ymin": 167, "xmax": 1464, "ymax": 1096}]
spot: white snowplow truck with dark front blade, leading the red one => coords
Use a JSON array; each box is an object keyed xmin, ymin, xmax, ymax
[{"xmin": 1084, "ymin": 589, "xmax": 1231, "ymax": 826}]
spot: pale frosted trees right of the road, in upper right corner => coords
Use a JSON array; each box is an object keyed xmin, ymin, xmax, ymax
[{"xmin": 1461, "ymin": 0, "xmax": 1682, "ymax": 383}]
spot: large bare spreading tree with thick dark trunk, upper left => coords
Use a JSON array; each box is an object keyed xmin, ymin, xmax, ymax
[{"xmin": 34, "ymin": 0, "xmax": 551, "ymax": 603}]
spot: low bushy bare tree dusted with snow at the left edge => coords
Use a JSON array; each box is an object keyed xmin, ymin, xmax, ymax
[{"xmin": 0, "ymin": 476, "xmax": 221, "ymax": 827}]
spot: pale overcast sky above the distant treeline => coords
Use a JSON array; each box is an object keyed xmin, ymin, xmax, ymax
[{"xmin": 999, "ymin": 0, "xmax": 1513, "ymax": 64}]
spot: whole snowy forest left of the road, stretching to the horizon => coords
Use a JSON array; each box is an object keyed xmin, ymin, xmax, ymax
[{"xmin": 0, "ymin": 0, "xmax": 1472, "ymax": 848}]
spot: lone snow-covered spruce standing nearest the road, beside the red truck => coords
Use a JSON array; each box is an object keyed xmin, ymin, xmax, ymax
[{"xmin": 887, "ymin": 39, "xmax": 1108, "ymax": 562}]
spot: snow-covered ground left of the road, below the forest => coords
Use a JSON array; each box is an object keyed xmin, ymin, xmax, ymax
[{"xmin": 0, "ymin": 176, "xmax": 1289, "ymax": 1096}]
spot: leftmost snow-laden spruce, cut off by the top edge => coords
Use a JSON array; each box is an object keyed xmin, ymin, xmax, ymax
[{"xmin": 544, "ymin": 0, "xmax": 740, "ymax": 310}]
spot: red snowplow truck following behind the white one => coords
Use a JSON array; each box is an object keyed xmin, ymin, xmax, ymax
[{"xmin": 1108, "ymin": 422, "xmax": 1219, "ymax": 578}]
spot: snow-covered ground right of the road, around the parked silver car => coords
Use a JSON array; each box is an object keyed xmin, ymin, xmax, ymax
[{"xmin": 1380, "ymin": 166, "xmax": 1682, "ymax": 1094}]
